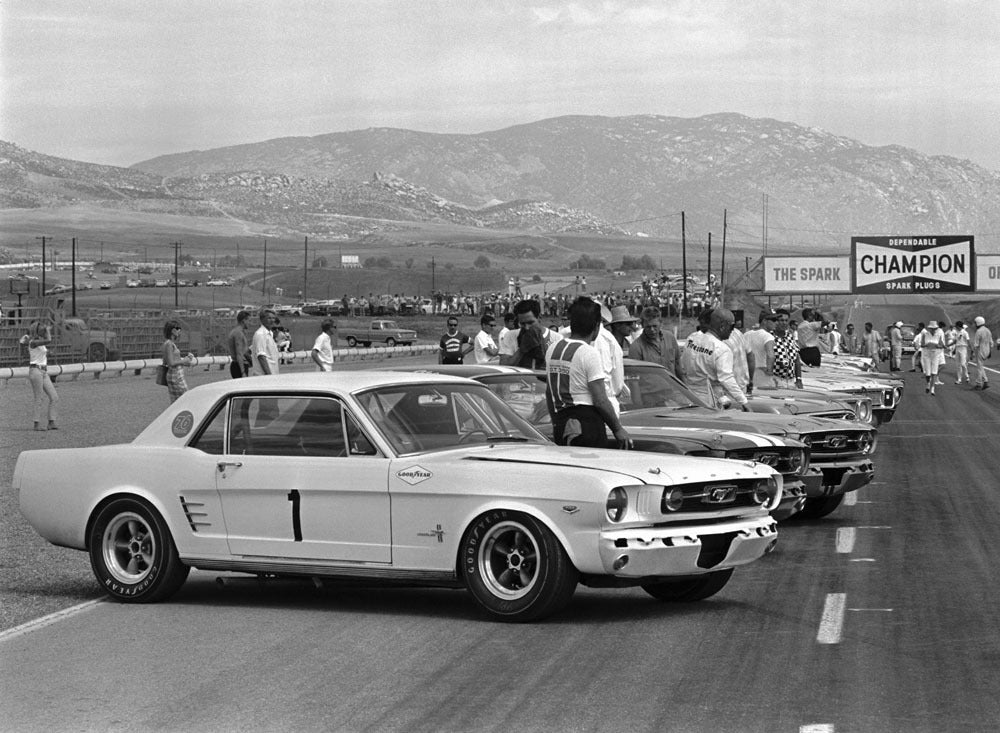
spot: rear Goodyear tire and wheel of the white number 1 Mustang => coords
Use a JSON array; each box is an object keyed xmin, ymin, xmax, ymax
[{"xmin": 87, "ymin": 499, "xmax": 189, "ymax": 603}]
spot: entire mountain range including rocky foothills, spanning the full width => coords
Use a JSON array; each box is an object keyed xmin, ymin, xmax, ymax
[{"xmin": 0, "ymin": 114, "xmax": 1000, "ymax": 251}]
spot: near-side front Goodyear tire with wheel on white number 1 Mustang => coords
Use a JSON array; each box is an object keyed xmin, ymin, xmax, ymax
[{"xmin": 459, "ymin": 509, "xmax": 579, "ymax": 622}]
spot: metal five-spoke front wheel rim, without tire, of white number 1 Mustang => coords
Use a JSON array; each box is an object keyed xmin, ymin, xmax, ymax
[{"xmin": 478, "ymin": 521, "xmax": 539, "ymax": 600}]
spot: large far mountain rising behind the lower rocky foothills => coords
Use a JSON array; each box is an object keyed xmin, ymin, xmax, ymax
[{"xmin": 134, "ymin": 114, "xmax": 1000, "ymax": 246}]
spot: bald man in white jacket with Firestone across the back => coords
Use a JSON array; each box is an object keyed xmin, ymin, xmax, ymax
[{"xmin": 682, "ymin": 308, "xmax": 750, "ymax": 412}]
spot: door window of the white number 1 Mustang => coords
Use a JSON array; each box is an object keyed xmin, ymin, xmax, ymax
[{"xmin": 229, "ymin": 396, "xmax": 347, "ymax": 457}]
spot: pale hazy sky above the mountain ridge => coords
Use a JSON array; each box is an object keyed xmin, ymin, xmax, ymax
[{"xmin": 0, "ymin": 0, "xmax": 1000, "ymax": 170}]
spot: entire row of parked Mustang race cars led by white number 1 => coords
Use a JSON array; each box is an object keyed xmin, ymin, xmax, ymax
[{"xmin": 13, "ymin": 357, "xmax": 903, "ymax": 621}]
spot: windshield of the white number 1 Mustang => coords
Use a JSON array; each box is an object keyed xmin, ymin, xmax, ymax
[{"xmin": 358, "ymin": 384, "xmax": 546, "ymax": 455}]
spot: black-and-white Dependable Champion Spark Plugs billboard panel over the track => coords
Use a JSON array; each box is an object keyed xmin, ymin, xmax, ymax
[{"xmin": 851, "ymin": 234, "xmax": 976, "ymax": 293}]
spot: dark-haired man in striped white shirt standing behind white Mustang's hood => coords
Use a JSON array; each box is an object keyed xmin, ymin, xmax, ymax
[{"xmin": 545, "ymin": 297, "xmax": 632, "ymax": 449}]
